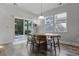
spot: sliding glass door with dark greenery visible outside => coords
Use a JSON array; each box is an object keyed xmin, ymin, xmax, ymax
[{"xmin": 15, "ymin": 18, "xmax": 32, "ymax": 35}]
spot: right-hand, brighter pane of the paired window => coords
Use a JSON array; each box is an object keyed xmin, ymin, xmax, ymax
[{"xmin": 55, "ymin": 12, "xmax": 67, "ymax": 32}]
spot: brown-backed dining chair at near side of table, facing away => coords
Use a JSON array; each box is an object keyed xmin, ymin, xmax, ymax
[{"xmin": 32, "ymin": 35, "xmax": 47, "ymax": 55}]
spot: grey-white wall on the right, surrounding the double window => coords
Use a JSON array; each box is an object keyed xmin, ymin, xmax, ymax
[{"xmin": 44, "ymin": 4, "xmax": 79, "ymax": 45}]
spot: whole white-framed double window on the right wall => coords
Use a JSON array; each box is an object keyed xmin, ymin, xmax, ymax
[{"xmin": 45, "ymin": 12, "xmax": 67, "ymax": 32}]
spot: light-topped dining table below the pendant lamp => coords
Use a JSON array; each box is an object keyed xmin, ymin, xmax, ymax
[{"xmin": 33, "ymin": 33, "xmax": 61, "ymax": 55}]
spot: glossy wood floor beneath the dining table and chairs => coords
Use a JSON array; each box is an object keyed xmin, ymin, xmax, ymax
[{"xmin": 0, "ymin": 43, "xmax": 79, "ymax": 56}]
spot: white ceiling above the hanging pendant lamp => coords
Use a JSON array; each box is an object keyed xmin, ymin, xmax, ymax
[{"xmin": 11, "ymin": 3, "xmax": 65, "ymax": 15}]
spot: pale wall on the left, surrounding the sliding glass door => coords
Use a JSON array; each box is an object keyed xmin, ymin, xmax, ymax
[{"xmin": 0, "ymin": 4, "xmax": 34, "ymax": 44}]
